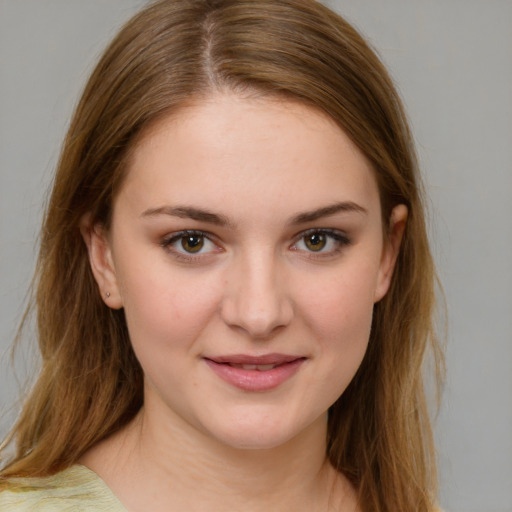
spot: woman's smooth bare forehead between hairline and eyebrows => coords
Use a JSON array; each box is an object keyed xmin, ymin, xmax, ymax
[{"xmin": 118, "ymin": 94, "xmax": 379, "ymax": 222}]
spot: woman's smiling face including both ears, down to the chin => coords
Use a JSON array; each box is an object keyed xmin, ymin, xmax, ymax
[{"xmin": 84, "ymin": 94, "xmax": 405, "ymax": 448}]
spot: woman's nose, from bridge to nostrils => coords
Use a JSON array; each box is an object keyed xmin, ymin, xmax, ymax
[{"xmin": 221, "ymin": 253, "xmax": 293, "ymax": 339}]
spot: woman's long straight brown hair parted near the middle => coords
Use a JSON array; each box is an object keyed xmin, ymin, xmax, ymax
[{"xmin": 2, "ymin": 0, "xmax": 442, "ymax": 512}]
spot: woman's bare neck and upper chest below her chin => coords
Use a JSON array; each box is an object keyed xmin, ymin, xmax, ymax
[{"xmin": 83, "ymin": 408, "xmax": 353, "ymax": 512}]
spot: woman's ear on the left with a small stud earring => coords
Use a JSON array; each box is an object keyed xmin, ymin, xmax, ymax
[{"xmin": 80, "ymin": 216, "xmax": 123, "ymax": 309}]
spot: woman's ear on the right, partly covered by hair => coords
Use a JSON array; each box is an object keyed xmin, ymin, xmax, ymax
[{"xmin": 374, "ymin": 204, "xmax": 408, "ymax": 302}]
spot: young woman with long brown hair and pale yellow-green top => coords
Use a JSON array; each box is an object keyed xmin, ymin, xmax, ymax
[{"xmin": 0, "ymin": 0, "xmax": 441, "ymax": 512}]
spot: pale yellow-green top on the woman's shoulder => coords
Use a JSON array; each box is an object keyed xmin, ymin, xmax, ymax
[{"xmin": 0, "ymin": 465, "xmax": 126, "ymax": 512}]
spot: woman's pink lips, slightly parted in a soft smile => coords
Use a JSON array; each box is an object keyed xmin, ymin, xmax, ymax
[{"xmin": 204, "ymin": 354, "xmax": 306, "ymax": 392}]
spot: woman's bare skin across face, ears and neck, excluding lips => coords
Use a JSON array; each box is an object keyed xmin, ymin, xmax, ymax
[{"xmin": 82, "ymin": 93, "xmax": 407, "ymax": 511}]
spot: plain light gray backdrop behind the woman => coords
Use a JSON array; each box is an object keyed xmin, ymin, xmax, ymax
[{"xmin": 0, "ymin": 0, "xmax": 512, "ymax": 512}]
